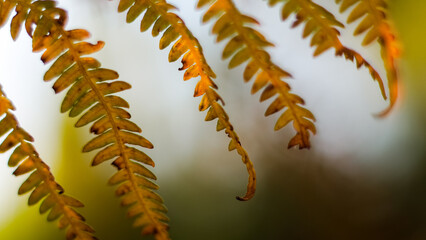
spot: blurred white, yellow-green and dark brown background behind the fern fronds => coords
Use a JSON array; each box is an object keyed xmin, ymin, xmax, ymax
[{"xmin": 0, "ymin": 0, "xmax": 426, "ymax": 240}]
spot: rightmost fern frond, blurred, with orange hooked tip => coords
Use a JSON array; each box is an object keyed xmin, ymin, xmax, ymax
[{"xmin": 336, "ymin": 0, "xmax": 400, "ymax": 116}]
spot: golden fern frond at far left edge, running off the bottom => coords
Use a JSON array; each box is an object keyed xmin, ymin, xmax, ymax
[{"xmin": 0, "ymin": 86, "xmax": 96, "ymax": 240}]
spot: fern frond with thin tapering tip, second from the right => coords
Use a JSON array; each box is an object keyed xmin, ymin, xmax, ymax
[{"xmin": 268, "ymin": 0, "xmax": 387, "ymax": 99}]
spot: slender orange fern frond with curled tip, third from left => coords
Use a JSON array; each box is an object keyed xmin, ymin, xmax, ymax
[{"xmin": 118, "ymin": 0, "xmax": 256, "ymax": 200}]
